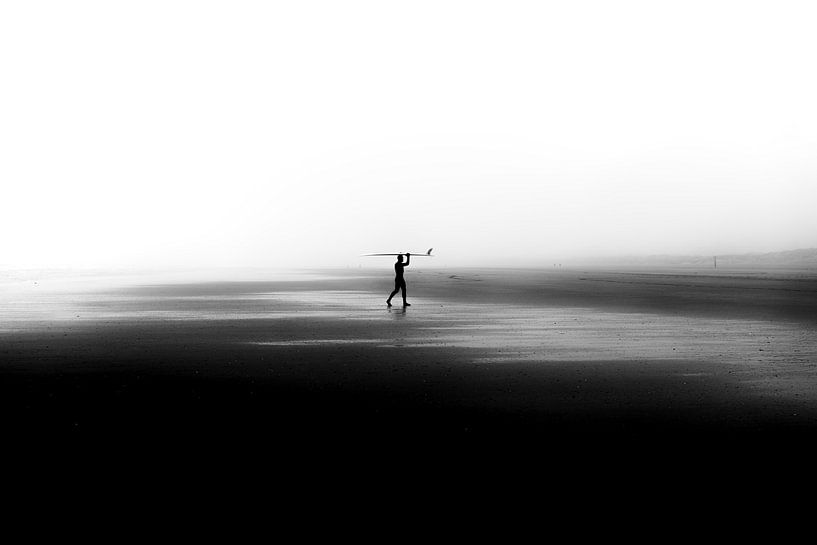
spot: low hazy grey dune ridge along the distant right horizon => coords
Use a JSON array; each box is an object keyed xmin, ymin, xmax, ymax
[{"xmin": 581, "ymin": 248, "xmax": 817, "ymax": 269}]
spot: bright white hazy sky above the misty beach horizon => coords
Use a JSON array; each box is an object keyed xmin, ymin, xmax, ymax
[{"xmin": 0, "ymin": 0, "xmax": 817, "ymax": 266}]
